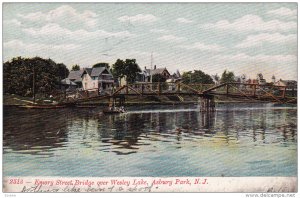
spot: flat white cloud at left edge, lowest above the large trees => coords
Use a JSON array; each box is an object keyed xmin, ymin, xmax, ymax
[{"xmin": 3, "ymin": 39, "xmax": 80, "ymax": 52}]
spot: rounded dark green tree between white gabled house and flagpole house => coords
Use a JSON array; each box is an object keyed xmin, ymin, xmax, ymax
[{"xmin": 112, "ymin": 59, "xmax": 141, "ymax": 83}]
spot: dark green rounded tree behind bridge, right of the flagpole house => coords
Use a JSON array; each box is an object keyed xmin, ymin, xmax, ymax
[{"xmin": 182, "ymin": 70, "xmax": 214, "ymax": 84}]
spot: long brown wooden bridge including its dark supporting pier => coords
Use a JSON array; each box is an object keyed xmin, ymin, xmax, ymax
[{"xmin": 62, "ymin": 83, "xmax": 297, "ymax": 110}]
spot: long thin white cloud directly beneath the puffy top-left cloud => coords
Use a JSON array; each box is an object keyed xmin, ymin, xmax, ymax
[{"xmin": 22, "ymin": 23, "xmax": 135, "ymax": 40}]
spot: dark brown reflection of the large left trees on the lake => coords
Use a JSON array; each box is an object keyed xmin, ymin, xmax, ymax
[{"xmin": 3, "ymin": 107, "xmax": 68, "ymax": 153}]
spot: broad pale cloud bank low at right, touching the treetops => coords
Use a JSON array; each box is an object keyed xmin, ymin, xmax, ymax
[{"xmin": 211, "ymin": 53, "xmax": 297, "ymax": 80}]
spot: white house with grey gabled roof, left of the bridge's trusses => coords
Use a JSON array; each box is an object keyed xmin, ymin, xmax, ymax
[{"xmin": 81, "ymin": 67, "xmax": 114, "ymax": 91}]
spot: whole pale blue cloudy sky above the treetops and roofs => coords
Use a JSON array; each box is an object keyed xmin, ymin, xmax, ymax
[{"xmin": 3, "ymin": 3, "xmax": 298, "ymax": 81}]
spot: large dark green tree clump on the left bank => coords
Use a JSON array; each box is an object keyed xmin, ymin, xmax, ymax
[{"xmin": 3, "ymin": 57, "xmax": 69, "ymax": 96}]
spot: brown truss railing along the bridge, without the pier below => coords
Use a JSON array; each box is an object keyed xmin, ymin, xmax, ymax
[{"xmin": 54, "ymin": 82, "xmax": 297, "ymax": 101}]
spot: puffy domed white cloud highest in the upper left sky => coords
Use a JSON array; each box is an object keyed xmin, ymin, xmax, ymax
[{"xmin": 18, "ymin": 5, "xmax": 98, "ymax": 27}]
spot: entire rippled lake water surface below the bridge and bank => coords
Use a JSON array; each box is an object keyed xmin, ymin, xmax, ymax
[{"xmin": 3, "ymin": 104, "xmax": 297, "ymax": 177}]
